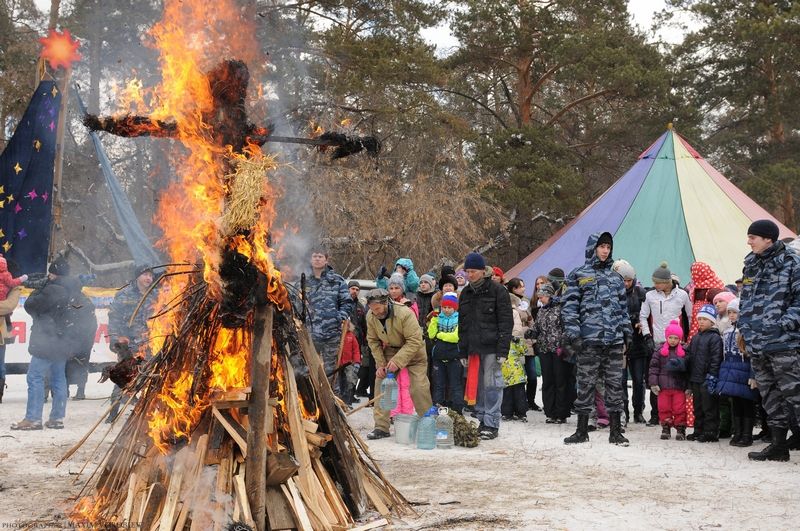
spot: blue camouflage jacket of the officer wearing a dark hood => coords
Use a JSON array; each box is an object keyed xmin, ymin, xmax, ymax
[{"xmin": 561, "ymin": 233, "xmax": 633, "ymax": 346}]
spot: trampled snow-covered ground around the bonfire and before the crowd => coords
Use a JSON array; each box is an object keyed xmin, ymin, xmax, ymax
[{"xmin": 0, "ymin": 375, "xmax": 800, "ymax": 530}]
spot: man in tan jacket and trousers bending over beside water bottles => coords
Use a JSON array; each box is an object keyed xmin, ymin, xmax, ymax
[{"xmin": 367, "ymin": 289, "xmax": 433, "ymax": 439}]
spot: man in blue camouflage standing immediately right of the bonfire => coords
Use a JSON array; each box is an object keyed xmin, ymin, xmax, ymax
[{"xmin": 305, "ymin": 249, "xmax": 354, "ymax": 375}]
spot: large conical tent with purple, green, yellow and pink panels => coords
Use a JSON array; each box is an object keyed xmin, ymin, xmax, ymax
[{"xmin": 506, "ymin": 127, "xmax": 795, "ymax": 287}]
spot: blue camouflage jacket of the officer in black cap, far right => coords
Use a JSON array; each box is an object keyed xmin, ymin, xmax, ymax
[{"xmin": 738, "ymin": 242, "xmax": 800, "ymax": 356}]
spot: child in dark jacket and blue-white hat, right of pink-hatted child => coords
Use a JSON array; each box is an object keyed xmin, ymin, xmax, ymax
[{"xmin": 687, "ymin": 304, "xmax": 722, "ymax": 442}]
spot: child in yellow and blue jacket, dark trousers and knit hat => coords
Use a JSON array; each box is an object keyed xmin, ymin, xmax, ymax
[{"xmin": 428, "ymin": 293, "xmax": 467, "ymax": 414}]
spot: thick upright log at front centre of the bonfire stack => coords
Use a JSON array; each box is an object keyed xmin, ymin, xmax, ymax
[{"xmin": 247, "ymin": 304, "xmax": 273, "ymax": 531}]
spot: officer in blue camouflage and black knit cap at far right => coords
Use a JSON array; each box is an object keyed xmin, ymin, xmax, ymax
[{"xmin": 738, "ymin": 219, "xmax": 800, "ymax": 461}]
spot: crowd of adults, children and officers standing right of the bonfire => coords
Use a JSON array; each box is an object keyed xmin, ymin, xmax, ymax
[{"xmin": 307, "ymin": 220, "xmax": 800, "ymax": 461}]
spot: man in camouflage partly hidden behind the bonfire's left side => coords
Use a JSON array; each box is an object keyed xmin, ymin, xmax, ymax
[{"xmin": 106, "ymin": 265, "xmax": 156, "ymax": 423}]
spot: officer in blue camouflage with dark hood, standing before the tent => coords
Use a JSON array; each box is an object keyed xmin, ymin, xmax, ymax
[{"xmin": 561, "ymin": 232, "xmax": 633, "ymax": 446}]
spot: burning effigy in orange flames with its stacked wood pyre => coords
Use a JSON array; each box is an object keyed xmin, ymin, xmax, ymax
[{"xmin": 64, "ymin": 0, "xmax": 410, "ymax": 530}]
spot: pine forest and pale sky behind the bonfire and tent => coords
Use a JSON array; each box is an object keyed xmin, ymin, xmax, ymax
[{"xmin": 0, "ymin": 0, "xmax": 800, "ymax": 285}]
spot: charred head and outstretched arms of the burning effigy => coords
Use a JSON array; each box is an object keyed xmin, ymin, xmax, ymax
[{"xmin": 83, "ymin": 60, "xmax": 381, "ymax": 159}]
